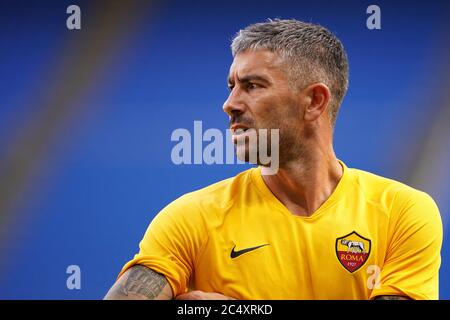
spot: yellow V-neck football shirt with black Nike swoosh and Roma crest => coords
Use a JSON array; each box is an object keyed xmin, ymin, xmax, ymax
[{"xmin": 119, "ymin": 162, "xmax": 442, "ymax": 299}]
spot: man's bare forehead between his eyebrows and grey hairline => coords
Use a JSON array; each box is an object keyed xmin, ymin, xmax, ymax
[{"xmin": 229, "ymin": 50, "xmax": 284, "ymax": 78}]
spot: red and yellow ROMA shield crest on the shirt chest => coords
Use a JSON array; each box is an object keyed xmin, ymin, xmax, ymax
[{"xmin": 336, "ymin": 231, "xmax": 371, "ymax": 273}]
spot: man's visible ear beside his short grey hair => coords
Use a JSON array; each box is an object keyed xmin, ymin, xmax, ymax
[{"xmin": 303, "ymin": 83, "xmax": 331, "ymax": 121}]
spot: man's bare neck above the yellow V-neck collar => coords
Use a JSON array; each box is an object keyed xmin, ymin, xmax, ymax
[{"xmin": 261, "ymin": 147, "xmax": 343, "ymax": 216}]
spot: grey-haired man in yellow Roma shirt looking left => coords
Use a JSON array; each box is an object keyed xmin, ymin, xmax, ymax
[{"xmin": 106, "ymin": 20, "xmax": 442, "ymax": 299}]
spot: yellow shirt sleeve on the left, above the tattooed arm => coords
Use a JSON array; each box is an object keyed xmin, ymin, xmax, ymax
[{"xmin": 118, "ymin": 197, "xmax": 207, "ymax": 297}]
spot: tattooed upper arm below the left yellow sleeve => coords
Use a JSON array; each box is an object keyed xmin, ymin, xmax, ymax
[{"xmin": 104, "ymin": 265, "xmax": 173, "ymax": 300}]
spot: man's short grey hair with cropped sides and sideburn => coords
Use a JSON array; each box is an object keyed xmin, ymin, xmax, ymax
[{"xmin": 231, "ymin": 19, "xmax": 348, "ymax": 127}]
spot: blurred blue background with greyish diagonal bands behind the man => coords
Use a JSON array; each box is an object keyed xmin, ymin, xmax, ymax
[{"xmin": 0, "ymin": 0, "xmax": 450, "ymax": 299}]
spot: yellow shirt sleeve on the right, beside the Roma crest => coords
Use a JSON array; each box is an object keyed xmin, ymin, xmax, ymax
[{"xmin": 371, "ymin": 190, "xmax": 443, "ymax": 300}]
